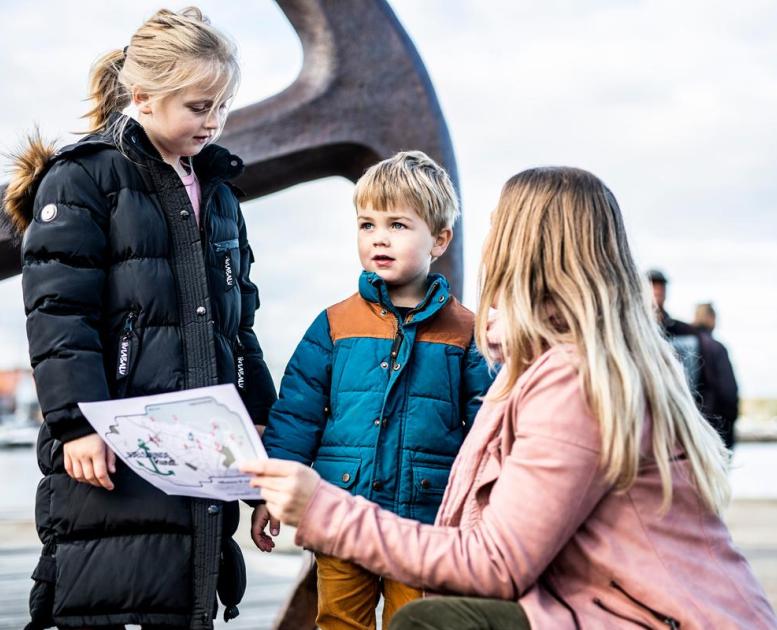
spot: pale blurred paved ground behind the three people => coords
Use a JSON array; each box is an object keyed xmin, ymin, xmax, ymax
[{"xmin": 0, "ymin": 500, "xmax": 777, "ymax": 630}]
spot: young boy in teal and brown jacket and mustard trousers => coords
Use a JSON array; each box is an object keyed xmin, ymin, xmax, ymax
[{"xmin": 260, "ymin": 151, "xmax": 491, "ymax": 629}]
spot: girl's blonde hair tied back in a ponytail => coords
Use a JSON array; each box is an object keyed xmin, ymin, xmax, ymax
[{"xmin": 84, "ymin": 7, "xmax": 240, "ymax": 136}]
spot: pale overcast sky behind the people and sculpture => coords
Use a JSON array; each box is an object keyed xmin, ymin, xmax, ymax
[{"xmin": 0, "ymin": 0, "xmax": 777, "ymax": 397}]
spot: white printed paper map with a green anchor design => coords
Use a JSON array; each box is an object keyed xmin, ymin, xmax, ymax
[{"xmin": 78, "ymin": 385, "xmax": 267, "ymax": 501}]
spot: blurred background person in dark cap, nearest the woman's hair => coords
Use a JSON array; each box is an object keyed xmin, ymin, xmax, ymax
[{"xmin": 647, "ymin": 269, "xmax": 705, "ymax": 398}]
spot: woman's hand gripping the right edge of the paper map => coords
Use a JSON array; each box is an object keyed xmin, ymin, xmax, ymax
[{"xmin": 240, "ymin": 459, "xmax": 321, "ymax": 527}]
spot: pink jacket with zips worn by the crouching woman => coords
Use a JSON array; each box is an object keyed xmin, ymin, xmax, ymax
[{"xmin": 296, "ymin": 346, "xmax": 777, "ymax": 630}]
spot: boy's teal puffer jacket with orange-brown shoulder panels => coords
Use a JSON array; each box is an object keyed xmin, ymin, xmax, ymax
[{"xmin": 263, "ymin": 272, "xmax": 492, "ymax": 523}]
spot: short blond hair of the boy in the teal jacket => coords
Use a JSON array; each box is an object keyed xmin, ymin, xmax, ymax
[{"xmin": 353, "ymin": 151, "xmax": 459, "ymax": 236}]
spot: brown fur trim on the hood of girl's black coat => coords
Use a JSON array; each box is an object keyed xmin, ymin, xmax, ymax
[{"xmin": 1, "ymin": 129, "xmax": 56, "ymax": 235}]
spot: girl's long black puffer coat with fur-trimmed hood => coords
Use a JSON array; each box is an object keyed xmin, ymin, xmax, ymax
[{"xmin": 6, "ymin": 116, "xmax": 275, "ymax": 628}]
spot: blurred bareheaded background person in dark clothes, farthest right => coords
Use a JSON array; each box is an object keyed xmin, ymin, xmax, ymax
[{"xmin": 693, "ymin": 303, "xmax": 739, "ymax": 449}]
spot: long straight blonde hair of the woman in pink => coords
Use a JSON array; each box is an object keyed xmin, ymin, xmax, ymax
[{"xmin": 475, "ymin": 167, "xmax": 730, "ymax": 511}]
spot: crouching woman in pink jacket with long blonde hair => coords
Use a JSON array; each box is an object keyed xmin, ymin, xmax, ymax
[{"xmin": 239, "ymin": 168, "xmax": 777, "ymax": 630}]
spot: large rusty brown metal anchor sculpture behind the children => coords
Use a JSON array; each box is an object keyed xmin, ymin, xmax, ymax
[{"xmin": 0, "ymin": 0, "xmax": 462, "ymax": 296}]
